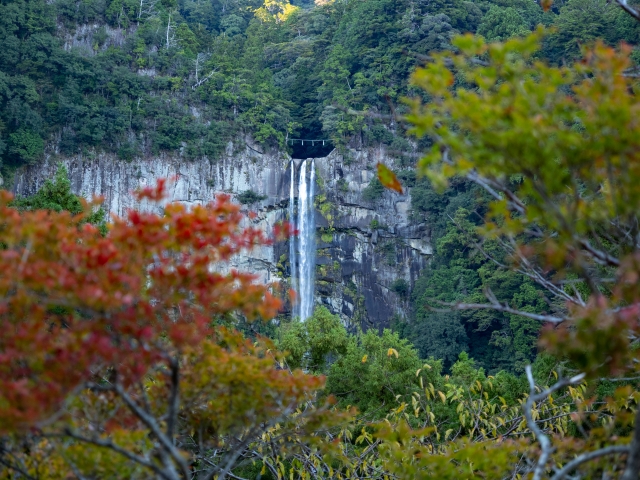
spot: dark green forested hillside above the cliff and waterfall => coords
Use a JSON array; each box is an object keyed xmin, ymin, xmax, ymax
[{"xmin": 0, "ymin": 0, "xmax": 640, "ymax": 171}]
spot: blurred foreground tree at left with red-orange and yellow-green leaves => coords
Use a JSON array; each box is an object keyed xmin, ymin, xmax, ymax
[{"xmin": 0, "ymin": 181, "xmax": 342, "ymax": 480}]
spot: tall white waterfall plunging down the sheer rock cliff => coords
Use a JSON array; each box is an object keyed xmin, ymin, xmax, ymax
[{"xmin": 289, "ymin": 159, "xmax": 316, "ymax": 321}]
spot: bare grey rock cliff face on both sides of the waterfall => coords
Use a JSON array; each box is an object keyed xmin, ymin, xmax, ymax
[{"xmin": 13, "ymin": 144, "xmax": 432, "ymax": 328}]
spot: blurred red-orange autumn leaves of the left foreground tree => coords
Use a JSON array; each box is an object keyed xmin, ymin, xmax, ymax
[{"xmin": 0, "ymin": 181, "xmax": 284, "ymax": 433}]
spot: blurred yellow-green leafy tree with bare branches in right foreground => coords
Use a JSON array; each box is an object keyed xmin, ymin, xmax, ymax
[{"xmin": 398, "ymin": 25, "xmax": 640, "ymax": 480}]
